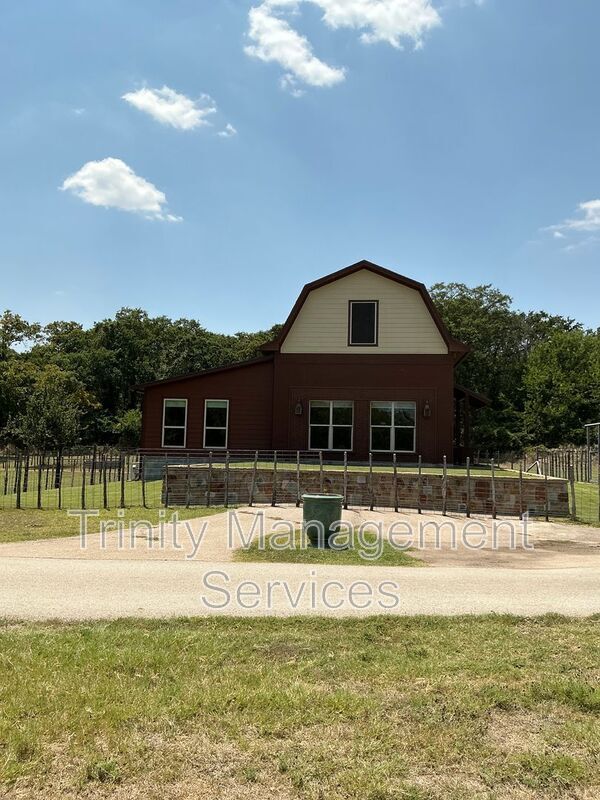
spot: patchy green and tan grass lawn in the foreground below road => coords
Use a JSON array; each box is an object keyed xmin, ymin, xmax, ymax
[{"xmin": 0, "ymin": 617, "xmax": 600, "ymax": 800}]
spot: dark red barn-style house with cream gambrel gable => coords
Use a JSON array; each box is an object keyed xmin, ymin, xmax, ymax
[{"xmin": 138, "ymin": 261, "xmax": 482, "ymax": 463}]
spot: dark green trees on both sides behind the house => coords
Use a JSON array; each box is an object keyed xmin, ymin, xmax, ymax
[{"xmin": 0, "ymin": 283, "xmax": 600, "ymax": 450}]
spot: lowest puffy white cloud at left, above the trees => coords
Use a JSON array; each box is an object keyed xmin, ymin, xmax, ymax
[{"xmin": 60, "ymin": 158, "xmax": 181, "ymax": 222}]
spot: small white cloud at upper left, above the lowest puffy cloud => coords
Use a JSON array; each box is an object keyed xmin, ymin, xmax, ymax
[{"xmin": 123, "ymin": 86, "xmax": 217, "ymax": 131}]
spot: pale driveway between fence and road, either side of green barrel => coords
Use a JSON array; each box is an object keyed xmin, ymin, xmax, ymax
[{"xmin": 0, "ymin": 506, "xmax": 600, "ymax": 569}]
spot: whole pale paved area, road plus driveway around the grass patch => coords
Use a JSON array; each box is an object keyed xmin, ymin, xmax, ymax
[{"xmin": 0, "ymin": 507, "xmax": 600, "ymax": 620}]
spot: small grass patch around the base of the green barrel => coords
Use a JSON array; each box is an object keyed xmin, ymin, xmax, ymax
[{"xmin": 234, "ymin": 531, "xmax": 424, "ymax": 567}]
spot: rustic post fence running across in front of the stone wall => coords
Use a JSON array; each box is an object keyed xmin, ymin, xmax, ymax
[{"xmin": 0, "ymin": 447, "xmax": 584, "ymax": 521}]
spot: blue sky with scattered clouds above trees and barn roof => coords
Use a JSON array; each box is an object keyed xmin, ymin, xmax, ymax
[{"xmin": 0, "ymin": 0, "xmax": 600, "ymax": 332}]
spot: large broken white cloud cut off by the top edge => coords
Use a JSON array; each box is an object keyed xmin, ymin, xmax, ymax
[{"xmin": 245, "ymin": 0, "xmax": 441, "ymax": 89}]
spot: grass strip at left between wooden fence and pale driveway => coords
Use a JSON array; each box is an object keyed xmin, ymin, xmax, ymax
[{"xmin": 0, "ymin": 507, "xmax": 224, "ymax": 543}]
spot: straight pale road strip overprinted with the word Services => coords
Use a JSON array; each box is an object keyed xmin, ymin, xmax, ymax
[{"xmin": 0, "ymin": 558, "xmax": 600, "ymax": 620}]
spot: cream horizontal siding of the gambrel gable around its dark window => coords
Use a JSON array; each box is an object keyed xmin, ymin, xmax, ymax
[{"xmin": 281, "ymin": 269, "xmax": 448, "ymax": 355}]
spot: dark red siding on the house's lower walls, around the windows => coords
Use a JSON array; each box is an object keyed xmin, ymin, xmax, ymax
[{"xmin": 142, "ymin": 353, "xmax": 454, "ymax": 463}]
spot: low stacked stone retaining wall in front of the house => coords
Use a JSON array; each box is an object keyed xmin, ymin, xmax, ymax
[{"xmin": 162, "ymin": 464, "xmax": 569, "ymax": 517}]
